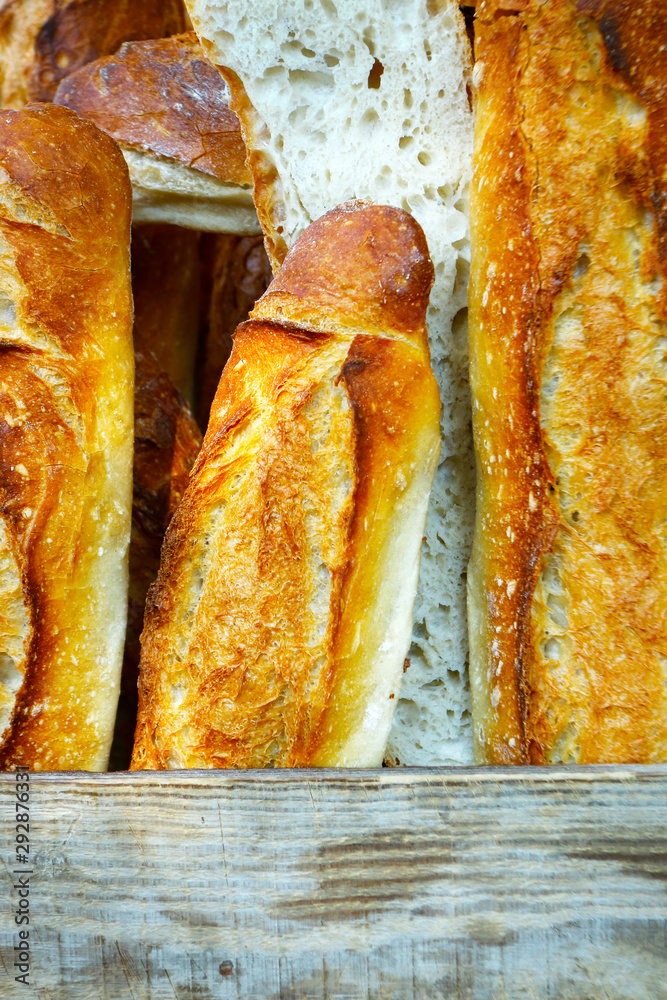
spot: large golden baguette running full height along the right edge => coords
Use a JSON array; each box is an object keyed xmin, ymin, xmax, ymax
[{"xmin": 469, "ymin": 0, "xmax": 667, "ymax": 763}]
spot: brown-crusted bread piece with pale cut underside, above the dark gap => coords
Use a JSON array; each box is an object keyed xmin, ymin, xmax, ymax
[{"xmin": 54, "ymin": 32, "xmax": 259, "ymax": 235}]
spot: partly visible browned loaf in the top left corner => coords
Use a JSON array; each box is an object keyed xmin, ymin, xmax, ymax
[{"xmin": 0, "ymin": 0, "xmax": 187, "ymax": 108}]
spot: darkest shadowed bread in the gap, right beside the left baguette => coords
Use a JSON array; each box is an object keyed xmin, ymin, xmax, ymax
[{"xmin": 132, "ymin": 225, "xmax": 200, "ymax": 407}]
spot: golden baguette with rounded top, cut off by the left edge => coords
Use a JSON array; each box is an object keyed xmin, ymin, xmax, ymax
[{"xmin": 0, "ymin": 105, "xmax": 134, "ymax": 770}]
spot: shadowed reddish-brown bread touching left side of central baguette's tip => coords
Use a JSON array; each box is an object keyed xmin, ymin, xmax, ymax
[{"xmin": 197, "ymin": 235, "xmax": 271, "ymax": 428}]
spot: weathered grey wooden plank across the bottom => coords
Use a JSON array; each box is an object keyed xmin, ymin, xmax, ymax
[{"xmin": 0, "ymin": 767, "xmax": 667, "ymax": 1000}]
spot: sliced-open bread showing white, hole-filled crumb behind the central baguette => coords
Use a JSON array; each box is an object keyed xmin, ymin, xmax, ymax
[{"xmin": 188, "ymin": 0, "xmax": 474, "ymax": 764}]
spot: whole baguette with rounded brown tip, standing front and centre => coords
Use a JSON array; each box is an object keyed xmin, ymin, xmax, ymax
[{"xmin": 132, "ymin": 205, "xmax": 439, "ymax": 769}]
